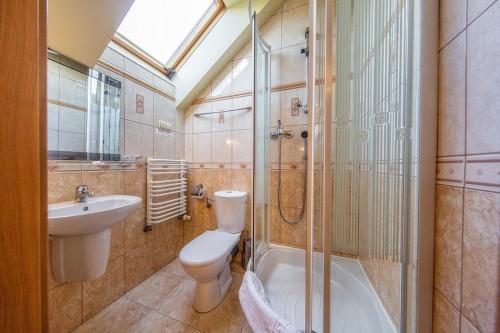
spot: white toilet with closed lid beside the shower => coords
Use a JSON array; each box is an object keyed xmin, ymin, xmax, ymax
[{"xmin": 179, "ymin": 190, "xmax": 248, "ymax": 312}]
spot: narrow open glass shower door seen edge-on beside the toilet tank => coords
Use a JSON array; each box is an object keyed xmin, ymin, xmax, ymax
[{"xmin": 252, "ymin": 13, "xmax": 271, "ymax": 270}]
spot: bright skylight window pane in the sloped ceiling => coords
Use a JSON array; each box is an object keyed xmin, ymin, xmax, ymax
[{"xmin": 118, "ymin": 0, "xmax": 221, "ymax": 65}]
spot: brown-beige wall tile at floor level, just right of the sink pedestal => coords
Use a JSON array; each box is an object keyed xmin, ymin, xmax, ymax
[{"xmin": 82, "ymin": 256, "xmax": 125, "ymax": 321}]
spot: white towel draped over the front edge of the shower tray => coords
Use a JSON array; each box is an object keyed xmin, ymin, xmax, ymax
[{"xmin": 239, "ymin": 271, "xmax": 303, "ymax": 333}]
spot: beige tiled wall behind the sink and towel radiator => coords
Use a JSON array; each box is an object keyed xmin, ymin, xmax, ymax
[{"xmin": 48, "ymin": 44, "xmax": 184, "ymax": 332}]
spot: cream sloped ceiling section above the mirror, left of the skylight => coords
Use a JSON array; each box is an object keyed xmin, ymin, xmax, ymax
[{"xmin": 47, "ymin": 0, "xmax": 134, "ymax": 67}]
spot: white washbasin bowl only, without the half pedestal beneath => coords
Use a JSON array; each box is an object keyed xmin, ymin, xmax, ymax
[{"xmin": 48, "ymin": 195, "xmax": 141, "ymax": 236}]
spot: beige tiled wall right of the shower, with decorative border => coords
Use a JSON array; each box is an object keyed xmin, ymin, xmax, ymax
[{"xmin": 434, "ymin": 0, "xmax": 500, "ymax": 333}]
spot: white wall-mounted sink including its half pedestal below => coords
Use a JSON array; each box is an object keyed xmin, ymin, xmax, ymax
[{"xmin": 48, "ymin": 195, "xmax": 141, "ymax": 282}]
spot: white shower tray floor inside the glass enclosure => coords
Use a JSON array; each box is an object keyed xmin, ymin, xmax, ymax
[{"xmin": 256, "ymin": 245, "xmax": 396, "ymax": 333}]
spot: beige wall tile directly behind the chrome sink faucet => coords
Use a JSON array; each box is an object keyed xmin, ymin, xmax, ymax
[{"xmin": 47, "ymin": 172, "xmax": 82, "ymax": 204}]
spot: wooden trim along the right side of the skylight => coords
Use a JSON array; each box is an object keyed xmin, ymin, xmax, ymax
[{"xmin": 171, "ymin": 0, "xmax": 226, "ymax": 71}]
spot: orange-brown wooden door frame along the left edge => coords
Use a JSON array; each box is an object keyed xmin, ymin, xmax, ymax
[{"xmin": 0, "ymin": 0, "xmax": 48, "ymax": 332}]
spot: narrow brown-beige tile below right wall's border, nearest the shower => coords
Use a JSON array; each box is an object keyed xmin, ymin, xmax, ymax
[{"xmin": 434, "ymin": 186, "xmax": 463, "ymax": 308}]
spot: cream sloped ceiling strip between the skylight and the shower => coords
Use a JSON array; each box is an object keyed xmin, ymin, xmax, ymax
[{"xmin": 173, "ymin": 0, "xmax": 283, "ymax": 110}]
